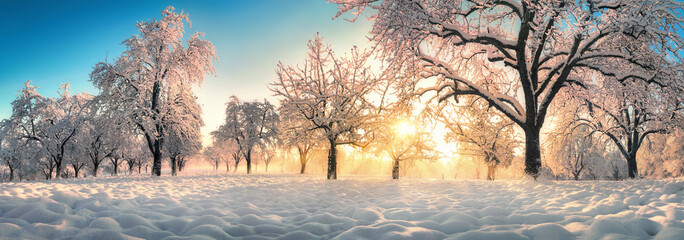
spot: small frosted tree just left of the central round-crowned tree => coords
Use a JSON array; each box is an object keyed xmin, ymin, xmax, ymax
[{"xmin": 213, "ymin": 96, "xmax": 279, "ymax": 173}]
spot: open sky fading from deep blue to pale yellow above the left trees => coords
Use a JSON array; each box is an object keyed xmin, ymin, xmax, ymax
[{"xmin": 0, "ymin": 0, "xmax": 371, "ymax": 143}]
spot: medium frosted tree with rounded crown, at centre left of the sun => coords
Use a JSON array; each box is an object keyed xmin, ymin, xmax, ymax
[{"xmin": 270, "ymin": 35, "xmax": 376, "ymax": 179}]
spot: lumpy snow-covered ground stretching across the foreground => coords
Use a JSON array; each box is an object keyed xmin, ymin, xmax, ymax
[{"xmin": 0, "ymin": 175, "xmax": 684, "ymax": 239}]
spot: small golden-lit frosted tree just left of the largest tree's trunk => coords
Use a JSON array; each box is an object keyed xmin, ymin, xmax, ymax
[{"xmin": 437, "ymin": 97, "xmax": 518, "ymax": 180}]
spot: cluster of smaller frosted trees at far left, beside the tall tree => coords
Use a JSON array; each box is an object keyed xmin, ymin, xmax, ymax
[{"xmin": 0, "ymin": 82, "xmax": 146, "ymax": 181}]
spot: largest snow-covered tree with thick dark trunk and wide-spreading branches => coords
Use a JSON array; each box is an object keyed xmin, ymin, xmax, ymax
[{"xmin": 332, "ymin": 0, "xmax": 683, "ymax": 178}]
